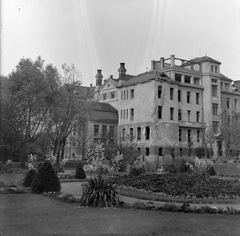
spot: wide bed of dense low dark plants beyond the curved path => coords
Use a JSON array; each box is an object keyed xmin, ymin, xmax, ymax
[{"xmin": 120, "ymin": 173, "xmax": 240, "ymax": 200}]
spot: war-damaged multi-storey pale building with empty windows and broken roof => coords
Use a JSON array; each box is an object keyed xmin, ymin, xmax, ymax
[{"xmin": 95, "ymin": 55, "xmax": 240, "ymax": 170}]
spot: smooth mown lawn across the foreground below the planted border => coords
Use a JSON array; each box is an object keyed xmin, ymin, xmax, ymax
[{"xmin": 0, "ymin": 194, "xmax": 240, "ymax": 236}]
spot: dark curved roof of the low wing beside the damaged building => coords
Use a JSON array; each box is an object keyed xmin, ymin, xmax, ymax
[{"xmin": 89, "ymin": 102, "xmax": 118, "ymax": 123}]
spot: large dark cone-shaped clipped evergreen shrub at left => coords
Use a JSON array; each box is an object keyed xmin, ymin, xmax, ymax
[{"xmin": 31, "ymin": 162, "xmax": 61, "ymax": 194}]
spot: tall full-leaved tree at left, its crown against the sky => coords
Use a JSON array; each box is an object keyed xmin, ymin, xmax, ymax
[{"xmin": 9, "ymin": 57, "xmax": 59, "ymax": 164}]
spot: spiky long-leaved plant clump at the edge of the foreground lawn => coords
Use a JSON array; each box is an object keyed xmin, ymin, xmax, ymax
[{"xmin": 80, "ymin": 174, "xmax": 119, "ymax": 207}]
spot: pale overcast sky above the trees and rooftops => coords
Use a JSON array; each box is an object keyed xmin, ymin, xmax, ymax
[{"xmin": 1, "ymin": 0, "xmax": 240, "ymax": 86}]
